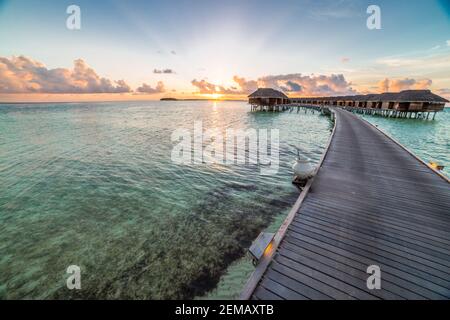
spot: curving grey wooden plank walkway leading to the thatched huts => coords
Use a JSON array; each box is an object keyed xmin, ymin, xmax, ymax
[{"xmin": 246, "ymin": 109, "xmax": 450, "ymax": 299}]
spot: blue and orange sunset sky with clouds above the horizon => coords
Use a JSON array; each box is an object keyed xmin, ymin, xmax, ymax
[{"xmin": 0, "ymin": 0, "xmax": 450, "ymax": 102}]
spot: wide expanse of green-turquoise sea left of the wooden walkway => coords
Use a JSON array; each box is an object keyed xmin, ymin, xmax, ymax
[{"xmin": 0, "ymin": 101, "xmax": 332, "ymax": 299}]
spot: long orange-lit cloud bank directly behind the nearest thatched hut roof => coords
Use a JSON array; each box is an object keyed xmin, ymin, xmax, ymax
[{"xmin": 191, "ymin": 73, "xmax": 356, "ymax": 96}]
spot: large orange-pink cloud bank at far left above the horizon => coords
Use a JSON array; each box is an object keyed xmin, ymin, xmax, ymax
[{"xmin": 0, "ymin": 56, "xmax": 131, "ymax": 93}]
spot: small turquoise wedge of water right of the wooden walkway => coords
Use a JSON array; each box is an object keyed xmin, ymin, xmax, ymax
[{"xmin": 362, "ymin": 106, "xmax": 450, "ymax": 177}]
